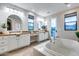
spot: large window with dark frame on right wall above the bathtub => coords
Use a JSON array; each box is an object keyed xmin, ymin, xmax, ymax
[{"xmin": 64, "ymin": 12, "xmax": 77, "ymax": 31}]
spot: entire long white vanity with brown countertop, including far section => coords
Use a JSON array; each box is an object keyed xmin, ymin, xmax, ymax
[{"xmin": 0, "ymin": 31, "xmax": 48, "ymax": 54}]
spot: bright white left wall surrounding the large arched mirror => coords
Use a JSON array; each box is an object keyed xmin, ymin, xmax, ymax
[{"xmin": 0, "ymin": 4, "xmax": 37, "ymax": 30}]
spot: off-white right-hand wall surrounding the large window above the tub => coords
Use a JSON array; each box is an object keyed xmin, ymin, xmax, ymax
[{"xmin": 46, "ymin": 8, "xmax": 79, "ymax": 40}]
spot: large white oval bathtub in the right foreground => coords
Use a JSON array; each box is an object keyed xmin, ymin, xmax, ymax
[{"xmin": 44, "ymin": 39, "xmax": 79, "ymax": 56}]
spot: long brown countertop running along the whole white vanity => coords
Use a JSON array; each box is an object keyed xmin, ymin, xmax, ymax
[{"xmin": 0, "ymin": 30, "xmax": 48, "ymax": 36}]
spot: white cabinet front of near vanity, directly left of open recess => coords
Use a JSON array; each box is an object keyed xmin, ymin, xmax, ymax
[{"xmin": 18, "ymin": 34, "xmax": 30, "ymax": 48}]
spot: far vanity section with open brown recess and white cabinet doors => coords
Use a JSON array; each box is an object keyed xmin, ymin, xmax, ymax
[{"xmin": 30, "ymin": 31, "xmax": 49, "ymax": 43}]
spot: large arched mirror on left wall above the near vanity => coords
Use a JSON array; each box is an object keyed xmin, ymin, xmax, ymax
[{"xmin": 7, "ymin": 15, "xmax": 22, "ymax": 31}]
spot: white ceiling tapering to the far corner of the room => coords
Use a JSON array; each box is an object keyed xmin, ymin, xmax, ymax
[{"xmin": 12, "ymin": 3, "xmax": 79, "ymax": 17}]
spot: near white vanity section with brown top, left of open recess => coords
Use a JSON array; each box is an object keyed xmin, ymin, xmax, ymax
[{"xmin": 0, "ymin": 32, "xmax": 30, "ymax": 54}]
